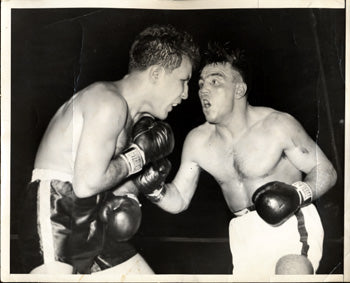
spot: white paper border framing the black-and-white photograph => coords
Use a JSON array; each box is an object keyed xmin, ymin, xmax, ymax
[{"xmin": 1, "ymin": 0, "xmax": 350, "ymax": 282}]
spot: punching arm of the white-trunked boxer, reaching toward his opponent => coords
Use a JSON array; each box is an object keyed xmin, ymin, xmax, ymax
[{"xmin": 157, "ymin": 131, "xmax": 201, "ymax": 214}]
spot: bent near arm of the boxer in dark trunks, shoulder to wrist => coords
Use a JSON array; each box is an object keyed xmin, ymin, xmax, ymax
[{"xmin": 73, "ymin": 91, "xmax": 128, "ymax": 197}]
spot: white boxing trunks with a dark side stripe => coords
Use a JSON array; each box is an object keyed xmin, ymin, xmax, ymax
[{"xmin": 229, "ymin": 204, "xmax": 324, "ymax": 281}]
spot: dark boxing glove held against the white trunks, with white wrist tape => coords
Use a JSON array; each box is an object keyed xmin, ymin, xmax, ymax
[{"xmin": 252, "ymin": 182, "xmax": 312, "ymax": 226}]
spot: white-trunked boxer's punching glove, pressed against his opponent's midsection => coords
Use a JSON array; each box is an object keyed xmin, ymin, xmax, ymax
[{"xmin": 133, "ymin": 158, "xmax": 171, "ymax": 202}]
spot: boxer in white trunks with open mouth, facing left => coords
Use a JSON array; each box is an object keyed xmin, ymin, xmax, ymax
[{"xmin": 139, "ymin": 41, "xmax": 337, "ymax": 280}]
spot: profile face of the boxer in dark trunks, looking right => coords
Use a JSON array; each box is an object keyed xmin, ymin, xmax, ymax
[{"xmin": 154, "ymin": 57, "xmax": 192, "ymax": 119}]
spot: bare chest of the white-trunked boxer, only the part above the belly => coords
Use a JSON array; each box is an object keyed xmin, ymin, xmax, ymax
[{"xmin": 203, "ymin": 127, "xmax": 288, "ymax": 187}]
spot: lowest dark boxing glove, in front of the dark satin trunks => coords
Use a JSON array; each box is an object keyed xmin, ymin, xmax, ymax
[{"xmin": 99, "ymin": 194, "xmax": 141, "ymax": 242}]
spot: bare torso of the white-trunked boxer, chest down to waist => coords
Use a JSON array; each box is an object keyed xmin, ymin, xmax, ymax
[{"xmin": 197, "ymin": 128, "xmax": 293, "ymax": 212}]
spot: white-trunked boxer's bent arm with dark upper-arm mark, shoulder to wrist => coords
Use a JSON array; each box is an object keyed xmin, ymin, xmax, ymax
[{"xmin": 280, "ymin": 115, "xmax": 337, "ymax": 200}]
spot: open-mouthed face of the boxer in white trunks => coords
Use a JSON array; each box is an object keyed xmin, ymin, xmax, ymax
[{"xmin": 198, "ymin": 63, "xmax": 240, "ymax": 123}]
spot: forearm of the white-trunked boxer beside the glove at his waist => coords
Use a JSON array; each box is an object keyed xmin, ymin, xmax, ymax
[{"xmin": 303, "ymin": 162, "xmax": 337, "ymax": 200}]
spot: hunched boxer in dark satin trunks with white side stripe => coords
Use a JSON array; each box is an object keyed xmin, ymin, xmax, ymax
[{"xmin": 19, "ymin": 26, "xmax": 199, "ymax": 274}]
